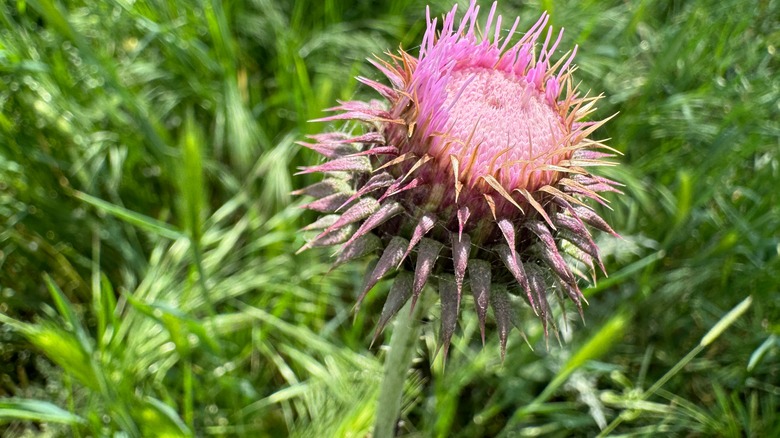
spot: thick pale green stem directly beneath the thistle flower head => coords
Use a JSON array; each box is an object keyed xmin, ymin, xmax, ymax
[{"xmin": 374, "ymin": 297, "xmax": 425, "ymax": 438}]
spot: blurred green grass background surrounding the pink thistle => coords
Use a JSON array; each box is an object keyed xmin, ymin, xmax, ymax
[{"xmin": 0, "ymin": 0, "xmax": 780, "ymax": 437}]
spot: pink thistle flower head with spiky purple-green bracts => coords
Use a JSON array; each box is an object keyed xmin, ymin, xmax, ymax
[{"xmin": 296, "ymin": 1, "xmax": 618, "ymax": 356}]
